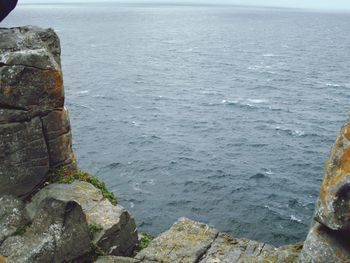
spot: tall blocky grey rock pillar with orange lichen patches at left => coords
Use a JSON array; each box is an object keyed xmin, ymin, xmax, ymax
[{"xmin": 0, "ymin": 27, "xmax": 75, "ymax": 197}]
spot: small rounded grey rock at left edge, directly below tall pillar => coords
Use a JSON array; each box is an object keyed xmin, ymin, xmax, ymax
[{"xmin": 0, "ymin": 196, "xmax": 29, "ymax": 245}]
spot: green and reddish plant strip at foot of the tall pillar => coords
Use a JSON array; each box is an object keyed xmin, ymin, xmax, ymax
[{"xmin": 48, "ymin": 167, "xmax": 117, "ymax": 205}]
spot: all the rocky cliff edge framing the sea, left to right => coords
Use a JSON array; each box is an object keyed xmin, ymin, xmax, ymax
[{"xmin": 0, "ymin": 26, "xmax": 350, "ymax": 263}]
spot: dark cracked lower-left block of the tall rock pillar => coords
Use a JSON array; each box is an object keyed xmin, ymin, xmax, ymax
[{"xmin": 0, "ymin": 117, "xmax": 49, "ymax": 196}]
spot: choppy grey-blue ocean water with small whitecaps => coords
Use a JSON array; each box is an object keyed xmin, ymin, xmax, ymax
[{"xmin": 1, "ymin": 4, "xmax": 350, "ymax": 245}]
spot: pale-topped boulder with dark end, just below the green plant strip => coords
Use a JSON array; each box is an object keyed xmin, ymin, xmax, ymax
[{"xmin": 26, "ymin": 181, "xmax": 138, "ymax": 256}]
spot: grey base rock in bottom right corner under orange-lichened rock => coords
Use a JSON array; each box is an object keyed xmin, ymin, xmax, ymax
[{"xmin": 300, "ymin": 223, "xmax": 350, "ymax": 263}]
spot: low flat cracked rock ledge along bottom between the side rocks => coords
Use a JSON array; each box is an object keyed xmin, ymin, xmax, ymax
[{"xmin": 136, "ymin": 218, "xmax": 301, "ymax": 263}]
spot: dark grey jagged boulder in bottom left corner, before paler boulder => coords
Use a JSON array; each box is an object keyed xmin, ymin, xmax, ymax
[{"xmin": 0, "ymin": 198, "xmax": 90, "ymax": 263}]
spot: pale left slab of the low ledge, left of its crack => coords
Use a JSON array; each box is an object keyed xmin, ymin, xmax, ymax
[{"xmin": 136, "ymin": 218, "xmax": 218, "ymax": 262}]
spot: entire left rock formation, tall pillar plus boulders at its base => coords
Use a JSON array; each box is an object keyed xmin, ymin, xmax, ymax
[{"xmin": 0, "ymin": 27, "xmax": 138, "ymax": 263}]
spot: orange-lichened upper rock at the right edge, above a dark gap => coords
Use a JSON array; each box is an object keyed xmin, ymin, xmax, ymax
[{"xmin": 315, "ymin": 119, "xmax": 350, "ymax": 230}]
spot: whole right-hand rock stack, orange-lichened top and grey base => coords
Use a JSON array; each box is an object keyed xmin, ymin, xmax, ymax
[{"xmin": 300, "ymin": 119, "xmax": 350, "ymax": 263}]
